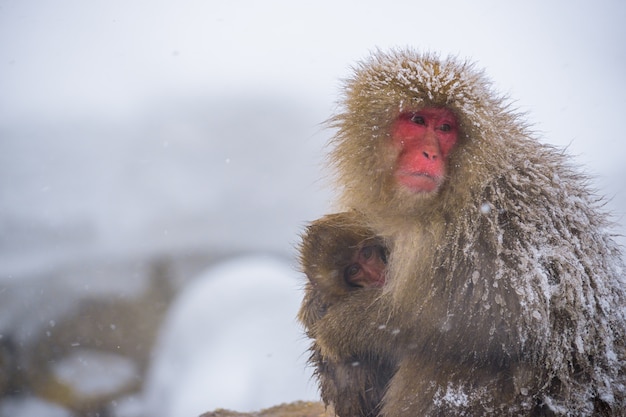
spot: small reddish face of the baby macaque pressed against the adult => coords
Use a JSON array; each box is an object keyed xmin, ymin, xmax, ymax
[{"xmin": 344, "ymin": 245, "xmax": 387, "ymax": 288}]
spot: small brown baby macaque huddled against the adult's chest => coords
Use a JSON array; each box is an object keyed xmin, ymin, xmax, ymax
[{"xmin": 299, "ymin": 213, "xmax": 395, "ymax": 416}]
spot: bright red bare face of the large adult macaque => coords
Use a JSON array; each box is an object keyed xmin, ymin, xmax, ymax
[{"xmin": 391, "ymin": 107, "xmax": 459, "ymax": 193}]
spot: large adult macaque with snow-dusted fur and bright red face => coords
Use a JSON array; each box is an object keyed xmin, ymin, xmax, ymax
[{"xmin": 300, "ymin": 50, "xmax": 626, "ymax": 417}]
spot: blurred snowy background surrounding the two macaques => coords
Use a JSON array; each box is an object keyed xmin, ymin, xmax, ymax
[{"xmin": 0, "ymin": 0, "xmax": 626, "ymax": 417}]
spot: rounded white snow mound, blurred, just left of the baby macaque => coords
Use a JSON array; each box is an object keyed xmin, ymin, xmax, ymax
[{"xmin": 146, "ymin": 256, "xmax": 319, "ymax": 417}]
